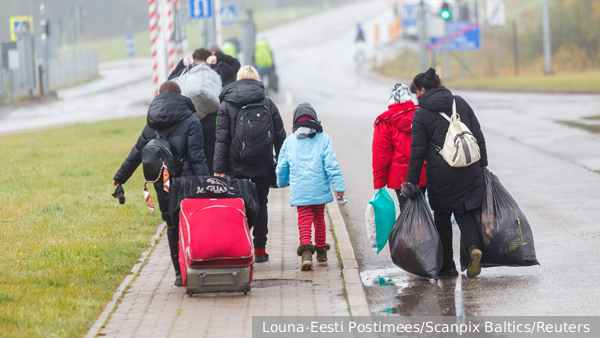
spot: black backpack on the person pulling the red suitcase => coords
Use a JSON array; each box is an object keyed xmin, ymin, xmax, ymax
[{"xmin": 142, "ymin": 119, "xmax": 187, "ymax": 182}]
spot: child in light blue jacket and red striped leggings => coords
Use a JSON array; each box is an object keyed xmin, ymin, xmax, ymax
[{"xmin": 276, "ymin": 103, "xmax": 346, "ymax": 271}]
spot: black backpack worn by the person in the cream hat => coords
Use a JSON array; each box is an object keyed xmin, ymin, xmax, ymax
[{"xmin": 230, "ymin": 100, "xmax": 275, "ymax": 164}]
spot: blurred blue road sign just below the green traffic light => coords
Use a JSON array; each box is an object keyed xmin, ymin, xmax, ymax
[{"xmin": 427, "ymin": 21, "xmax": 481, "ymax": 52}]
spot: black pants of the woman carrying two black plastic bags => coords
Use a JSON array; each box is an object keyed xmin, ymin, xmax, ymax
[{"xmin": 433, "ymin": 210, "xmax": 479, "ymax": 271}]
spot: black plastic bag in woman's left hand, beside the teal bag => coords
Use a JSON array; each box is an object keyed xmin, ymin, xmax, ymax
[{"xmin": 389, "ymin": 191, "xmax": 444, "ymax": 280}]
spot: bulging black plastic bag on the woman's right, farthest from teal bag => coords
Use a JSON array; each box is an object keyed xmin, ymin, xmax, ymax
[{"xmin": 460, "ymin": 170, "xmax": 540, "ymax": 271}]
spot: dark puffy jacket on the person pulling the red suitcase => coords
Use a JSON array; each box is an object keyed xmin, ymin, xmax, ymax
[{"xmin": 114, "ymin": 92, "xmax": 208, "ymax": 184}]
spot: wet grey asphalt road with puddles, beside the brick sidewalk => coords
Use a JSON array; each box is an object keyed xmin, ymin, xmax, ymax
[{"xmin": 0, "ymin": 2, "xmax": 600, "ymax": 315}]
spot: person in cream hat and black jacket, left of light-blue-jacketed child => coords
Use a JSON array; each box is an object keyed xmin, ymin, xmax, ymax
[{"xmin": 214, "ymin": 66, "xmax": 285, "ymax": 263}]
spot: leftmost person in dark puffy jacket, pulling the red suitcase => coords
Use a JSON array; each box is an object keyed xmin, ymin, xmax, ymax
[{"xmin": 113, "ymin": 81, "xmax": 208, "ymax": 286}]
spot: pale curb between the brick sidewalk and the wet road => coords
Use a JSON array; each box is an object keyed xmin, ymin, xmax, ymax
[{"xmin": 327, "ymin": 202, "xmax": 371, "ymax": 317}]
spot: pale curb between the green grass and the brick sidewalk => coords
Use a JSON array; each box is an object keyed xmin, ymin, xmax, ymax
[{"xmin": 85, "ymin": 222, "xmax": 167, "ymax": 338}]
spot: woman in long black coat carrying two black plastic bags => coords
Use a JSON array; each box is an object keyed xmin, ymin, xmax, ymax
[{"xmin": 402, "ymin": 68, "xmax": 488, "ymax": 278}]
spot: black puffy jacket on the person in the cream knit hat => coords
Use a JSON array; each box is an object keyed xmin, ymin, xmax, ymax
[{"xmin": 214, "ymin": 79, "xmax": 285, "ymax": 178}]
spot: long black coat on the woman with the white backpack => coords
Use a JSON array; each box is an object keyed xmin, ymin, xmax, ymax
[{"xmin": 407, "ymin": 87, "xmax": 488, "ymax": 213}]
